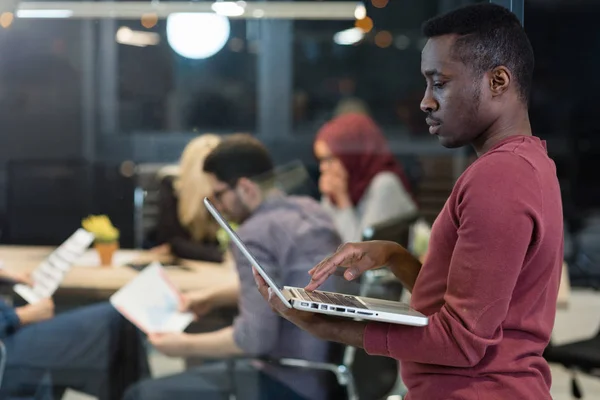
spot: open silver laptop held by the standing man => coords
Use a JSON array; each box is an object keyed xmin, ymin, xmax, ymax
[{"xmin": 204, "ymin": 198, "xmax": 429, "ymax": 326}]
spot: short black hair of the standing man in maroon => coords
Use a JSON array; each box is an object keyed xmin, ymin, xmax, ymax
[{"xmin": 423, "ymin": 3, "xmax": 534, "ymax": 102}]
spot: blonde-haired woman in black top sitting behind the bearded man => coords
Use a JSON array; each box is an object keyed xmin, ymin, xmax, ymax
[{"xmin": 153, "ymin": 134, "xmax": 223, "ymax": 262}]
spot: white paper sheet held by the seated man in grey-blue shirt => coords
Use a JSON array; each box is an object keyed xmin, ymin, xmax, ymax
[{"xmin": 110, "ymin": 263, "xmax": 194, "ymax": 334}]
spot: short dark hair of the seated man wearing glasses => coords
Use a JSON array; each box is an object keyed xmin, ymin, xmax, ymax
[{"xmin": 204, "ymin": 133, "xmax": 273, "ymax": 187}]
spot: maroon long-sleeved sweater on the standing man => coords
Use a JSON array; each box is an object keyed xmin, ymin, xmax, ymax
[{"xmin": 364, "ymin": 136, "xmax": 563, "ymax": 400}]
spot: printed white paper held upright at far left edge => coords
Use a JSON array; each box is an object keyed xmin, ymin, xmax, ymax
[{"xmin": 14, "ymin": 228, "xmax": 94, "ymax": 304}]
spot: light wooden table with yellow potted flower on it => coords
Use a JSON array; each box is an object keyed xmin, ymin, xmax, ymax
[{"xmin": 0, "ymin": 246, "xmax": 237, "ymax": 298}]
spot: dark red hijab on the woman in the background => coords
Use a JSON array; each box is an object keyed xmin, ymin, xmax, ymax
[{"xmin": 315, "ymin": 114, "xmax": 412, "ymax": 206}]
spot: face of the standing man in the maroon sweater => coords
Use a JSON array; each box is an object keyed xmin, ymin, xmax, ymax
[{"xmin": 421, "ymin": 35, "xmax": 489, "ymax": 148}]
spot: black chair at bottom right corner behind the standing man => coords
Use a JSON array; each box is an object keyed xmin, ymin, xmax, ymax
[{"xmin": 544, "ymin": 329, "xmax": 600, "ymax": 399}]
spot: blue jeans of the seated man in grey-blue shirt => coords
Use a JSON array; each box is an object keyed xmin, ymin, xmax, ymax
[{"xmin": 123, "ymin": 361, "xmax": 305, "ymax": 400}]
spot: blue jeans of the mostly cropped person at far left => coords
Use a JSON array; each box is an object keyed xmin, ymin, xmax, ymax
[{"xmin": 0, "ymin": 303, "xmax": 149, "ymax": 400}]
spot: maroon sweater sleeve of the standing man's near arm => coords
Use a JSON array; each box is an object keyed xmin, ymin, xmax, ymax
[{"xmin": 364, "ymin": 153, "xmax": 542, "ymax": 367}]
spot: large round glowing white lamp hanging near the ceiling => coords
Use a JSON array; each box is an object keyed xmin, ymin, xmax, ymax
[{"xmin": 167, "ymin": 13, "xmax": 231, "ymax": 60}]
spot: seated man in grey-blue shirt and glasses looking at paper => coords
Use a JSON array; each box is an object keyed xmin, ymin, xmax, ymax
[{"xmin": 125, "ymin": 134, "xmax": 341, "ymax": 400}]
